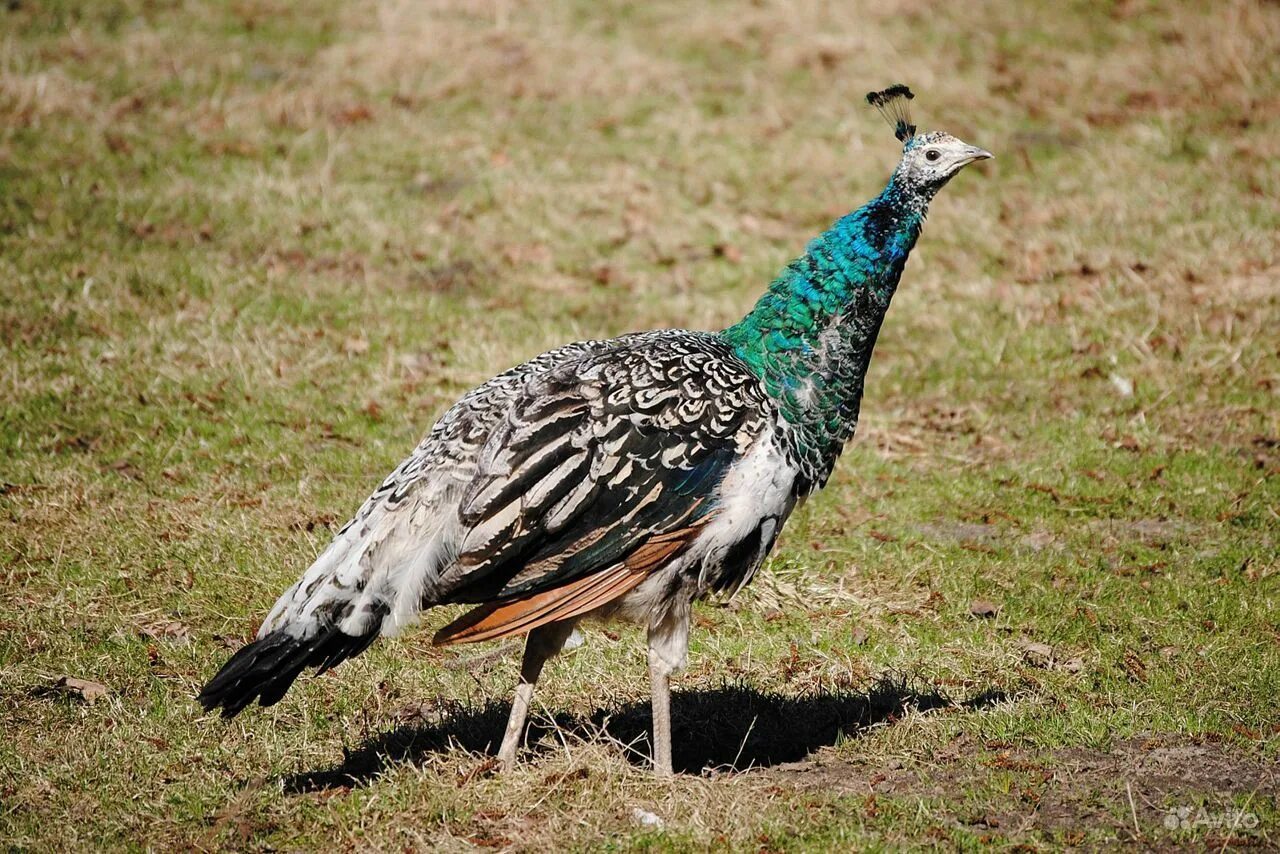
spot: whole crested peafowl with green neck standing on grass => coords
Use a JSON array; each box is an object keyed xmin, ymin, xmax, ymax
[{"xmin": 198, "ymin": 85, "xmax": 992, "ymax": 776}]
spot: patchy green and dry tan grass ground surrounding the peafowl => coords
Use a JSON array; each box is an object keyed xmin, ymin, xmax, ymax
[{"xmin": 0, "ymin": 0, "xmax": 1280, "ymax": 850}]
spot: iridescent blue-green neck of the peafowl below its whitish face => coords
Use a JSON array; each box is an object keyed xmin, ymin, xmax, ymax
[{"xmin": 721, "ymin": 174, "xmax": 932, "ymax": 488}]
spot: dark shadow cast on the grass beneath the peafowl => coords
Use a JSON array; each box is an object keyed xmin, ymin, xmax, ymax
[{"xmin": 284, "ymin": 680, "xmax": 1006, "ymax": 793}]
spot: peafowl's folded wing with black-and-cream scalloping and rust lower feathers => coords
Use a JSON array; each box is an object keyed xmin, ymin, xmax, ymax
[{"xmin": 439, "ymin": 333, "xmax": 767, "ymax": 640}]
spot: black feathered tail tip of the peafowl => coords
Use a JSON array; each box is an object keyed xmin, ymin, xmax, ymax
[{"xmin": 196, "ymin": 625, "xmax": 379, "ymax": 718}]
